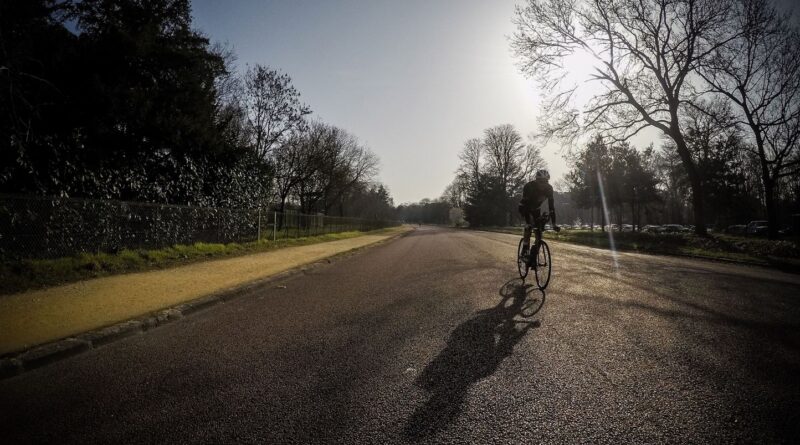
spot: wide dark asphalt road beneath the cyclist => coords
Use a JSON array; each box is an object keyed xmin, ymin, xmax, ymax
[{"xmin": 0, "ymin": 227, "xmax": 800, "ymax": 444}]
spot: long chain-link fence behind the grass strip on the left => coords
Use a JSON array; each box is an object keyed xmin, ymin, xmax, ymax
[{"xmin": 0, "ymin": 195, "xmax": 399, "ymax": 261}]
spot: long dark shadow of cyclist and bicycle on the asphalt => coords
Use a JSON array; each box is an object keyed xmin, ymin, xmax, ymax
[{"xmin": 404, "ymin": 278, "xmax": 545, "ymax": 438}]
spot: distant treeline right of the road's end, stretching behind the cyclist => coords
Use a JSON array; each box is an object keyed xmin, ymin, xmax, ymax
[{"xmin": 438, "ymin": 127, "xmax": 800, "ymax": 229}]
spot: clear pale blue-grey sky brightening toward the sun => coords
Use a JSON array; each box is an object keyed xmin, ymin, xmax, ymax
[{"xmin": 192, "ymin": 0, "xmax": 793, "ymax": 204}]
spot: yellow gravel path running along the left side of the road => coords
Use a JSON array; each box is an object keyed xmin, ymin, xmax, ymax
[{"xmin": 0, "ymin": 228, "xmax": 409, "ymax": 354}]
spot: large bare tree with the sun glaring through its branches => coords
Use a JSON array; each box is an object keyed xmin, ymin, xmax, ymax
[{"xmin": 512, "ymin": 0, "xmax": 732, "ymax": 234}]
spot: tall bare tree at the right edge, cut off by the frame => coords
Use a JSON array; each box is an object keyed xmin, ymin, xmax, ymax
[{"xmin": 699, "ymin": 0, "xmax": 800, "ymax": 239}]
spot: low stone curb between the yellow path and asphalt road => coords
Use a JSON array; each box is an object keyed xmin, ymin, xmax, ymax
[{"xmin": 0, "ymin": 230, "xmax": 413, "ymax": 380}]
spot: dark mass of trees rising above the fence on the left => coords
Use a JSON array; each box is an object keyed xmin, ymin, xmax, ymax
[{"xmin": 0, "ymin": 0, "xmax": 393, "ymax": 218}]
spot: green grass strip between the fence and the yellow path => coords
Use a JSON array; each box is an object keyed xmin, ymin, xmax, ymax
[{"xmin": 0, "ymin": 228, "xmax": 397, "ymax": 295}]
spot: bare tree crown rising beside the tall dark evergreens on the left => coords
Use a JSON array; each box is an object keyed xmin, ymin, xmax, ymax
[{"xmin": 244, "ymin": 65, "xmax": 311, "ymax": 159}]
